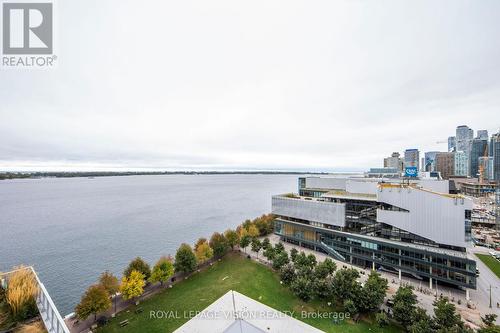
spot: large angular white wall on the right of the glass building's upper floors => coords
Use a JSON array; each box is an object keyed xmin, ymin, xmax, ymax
[{"xmin": 377, "ymin": 187, "xmax": 472, "ymax": 247}]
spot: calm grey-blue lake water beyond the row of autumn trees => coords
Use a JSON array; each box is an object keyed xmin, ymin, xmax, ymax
[{"xmin": 0, "ymin": 175, "xmax": 298, "ymax": 315}]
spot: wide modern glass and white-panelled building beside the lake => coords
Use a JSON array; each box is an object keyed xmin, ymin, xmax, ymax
[{"xmin": 272, "ymin": 177, "xmax": 476, "ymax": 289}]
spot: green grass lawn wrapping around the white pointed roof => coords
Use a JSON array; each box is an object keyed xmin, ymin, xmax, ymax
[{"xmin": 99, "ymin": 254, "xmax": 399, "ymax": 333}]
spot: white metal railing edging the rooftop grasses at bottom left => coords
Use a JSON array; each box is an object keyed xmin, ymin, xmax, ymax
[{"xmin": 0, "ymin": 266, "xmax": 70, "ymax": 333}]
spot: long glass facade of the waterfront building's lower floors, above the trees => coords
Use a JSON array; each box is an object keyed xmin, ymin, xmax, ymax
[{"xmin": 275, "ymin": 218, "xmax": 476, "ymax": 289}]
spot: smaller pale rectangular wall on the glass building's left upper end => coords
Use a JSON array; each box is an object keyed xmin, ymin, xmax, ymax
[{"xmin": 272, "ymin": 196, "xmax": 345, "ymax": 227}]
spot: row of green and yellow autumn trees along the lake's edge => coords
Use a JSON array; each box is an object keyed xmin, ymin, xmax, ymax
[{"xmin": 75, "ymin": 214, "xmax": 274, "ymax": 321}]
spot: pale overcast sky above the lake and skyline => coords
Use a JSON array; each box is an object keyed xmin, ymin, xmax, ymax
[{"xmin": 0, "ymin": 0, "xmax": 500, "ymax": 171}]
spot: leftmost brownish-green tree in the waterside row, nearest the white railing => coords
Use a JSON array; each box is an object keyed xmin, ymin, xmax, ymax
[{"xmin": 75, "ymin": 284, "xmax": 111, "ymax": 321}]
